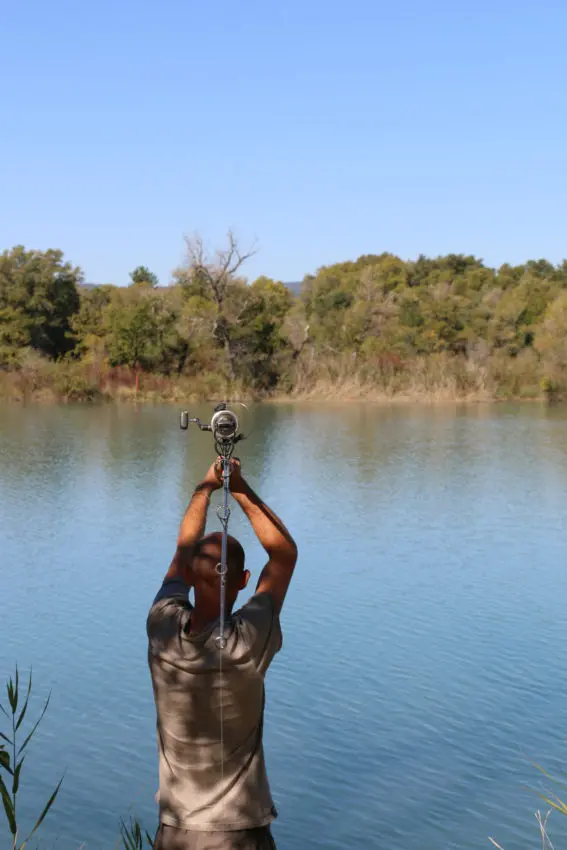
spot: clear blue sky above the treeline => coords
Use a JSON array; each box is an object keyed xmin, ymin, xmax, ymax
[{"xmin": 0, "ymin": 0, "xmax": 567, "ymax": 283}]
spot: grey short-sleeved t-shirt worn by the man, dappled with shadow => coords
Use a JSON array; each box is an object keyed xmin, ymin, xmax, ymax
[{"xmin": 147, "ymin": 581, "xmax": 282, "ymax": 831}]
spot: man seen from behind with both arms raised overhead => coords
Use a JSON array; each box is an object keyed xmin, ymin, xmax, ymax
[{"xmin": 147, "ymin": 459, "xmax": 297, "ymax": 850}]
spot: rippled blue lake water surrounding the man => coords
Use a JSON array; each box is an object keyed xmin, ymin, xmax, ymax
[{"xmin": 0, "ymin": 405, "xmax": 567, "ymax": 850}]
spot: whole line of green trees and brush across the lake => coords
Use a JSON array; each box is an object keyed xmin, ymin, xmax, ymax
[{"xmin": 0, "ymin": 233, "xmax": 567, "ymax": 398}]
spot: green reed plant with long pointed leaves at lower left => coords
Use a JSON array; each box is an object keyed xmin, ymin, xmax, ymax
[{"xmin": 0, "ymin": 667, "xmax": 63, "ymax": 850}]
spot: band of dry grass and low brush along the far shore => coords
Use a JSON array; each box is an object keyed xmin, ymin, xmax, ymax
[{"xmin": 0, "ymin": 354, "xmax": 567, "ymax": 403}]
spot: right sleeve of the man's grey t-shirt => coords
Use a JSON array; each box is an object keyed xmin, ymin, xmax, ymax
[{"xmin": 234, "ymin": 593, "xmax": 282, "ymax": 673}]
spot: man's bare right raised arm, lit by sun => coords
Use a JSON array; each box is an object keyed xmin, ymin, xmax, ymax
[{"xmin": 230, "ymin": 459, "xmax": 297, "ymax": 613}]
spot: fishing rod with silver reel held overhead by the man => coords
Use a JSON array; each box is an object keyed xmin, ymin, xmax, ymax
[{"xmin": 179, "ymin": 402, "xmax": 245, "ymax": 650}]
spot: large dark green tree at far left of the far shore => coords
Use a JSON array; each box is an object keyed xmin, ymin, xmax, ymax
[{"xmin": 0, "ymin": 245, "xmax": 82, "ymax": 365}]
